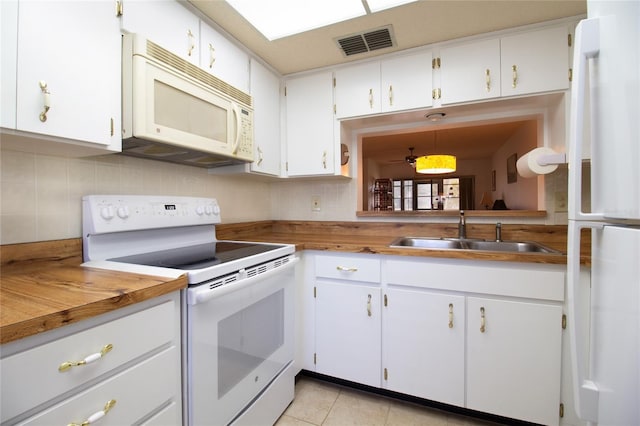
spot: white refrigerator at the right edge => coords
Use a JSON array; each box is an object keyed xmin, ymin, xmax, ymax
[{"xmin": 567, "ymin": 0, "xmax": 640, "ymax": 426}]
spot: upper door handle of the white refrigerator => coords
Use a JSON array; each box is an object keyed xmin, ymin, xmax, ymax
[{"xmin": 568, "ymin": 18, "xmax": 604, "ymax": 220}]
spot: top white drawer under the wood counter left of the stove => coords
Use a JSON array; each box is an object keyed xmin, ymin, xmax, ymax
[{"xmin": 0, "ymin": 298, "xmax": 180, "ymax": 422}]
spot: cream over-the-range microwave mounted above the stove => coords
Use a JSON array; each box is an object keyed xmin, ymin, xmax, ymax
[{"xmin": 122, "ymin": 34, "xmax": 253, "ymax": 168}]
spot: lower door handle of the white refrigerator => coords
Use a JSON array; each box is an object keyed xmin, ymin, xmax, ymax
[{"xmin": 567, "ymin": 220, "xmax": 604, "ymax": 422}]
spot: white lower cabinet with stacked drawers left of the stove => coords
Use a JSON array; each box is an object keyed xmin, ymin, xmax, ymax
[{"xmin": 0, "ymin": 292, "xmax": 182, "ymax": 425}]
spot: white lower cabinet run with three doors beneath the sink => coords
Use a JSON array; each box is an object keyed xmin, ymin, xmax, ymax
[{"xmin": 305, "ymin": 253, "xmax": 565, "ymax": 425}]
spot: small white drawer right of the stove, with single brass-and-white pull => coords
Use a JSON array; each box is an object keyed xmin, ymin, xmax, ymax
[{"xmin": 316, "ymin": 255, "xmax": 380, "ymax": 283}]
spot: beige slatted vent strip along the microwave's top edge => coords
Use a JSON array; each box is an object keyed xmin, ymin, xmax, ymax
[{"xmin": 147, "ymin": 40, "xmax": 252, "ymax": 107}]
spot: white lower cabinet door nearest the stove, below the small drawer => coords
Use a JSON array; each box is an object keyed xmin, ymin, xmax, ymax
[{"xmin": 316, "ymin": 280, "xmax": 381, "ymax": 387}]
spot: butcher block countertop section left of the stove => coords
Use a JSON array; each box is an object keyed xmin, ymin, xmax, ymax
[{"xmin": 0, "ymin": 238, "xmax": 187, "ymax": 343}]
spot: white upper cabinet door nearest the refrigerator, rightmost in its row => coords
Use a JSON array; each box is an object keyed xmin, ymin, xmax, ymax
[{"xmin": 500, "ymin": 26, "xmax": 569, "ymax": 96}]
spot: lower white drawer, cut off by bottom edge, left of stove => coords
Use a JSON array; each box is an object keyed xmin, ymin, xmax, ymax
[{"xmin": 20, "ymin": 346, "xmax": 181, "ymax": 426}]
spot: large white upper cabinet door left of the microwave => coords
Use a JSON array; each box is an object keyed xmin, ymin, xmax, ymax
[{"xmin": 16, "ymin": 1, "xmax": 122, "ymax": 151}]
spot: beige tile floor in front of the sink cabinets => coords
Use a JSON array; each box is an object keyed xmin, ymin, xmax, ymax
[{"xmin": 275, "ymin": 377, "xmax": 497, "ymax": 426}]
